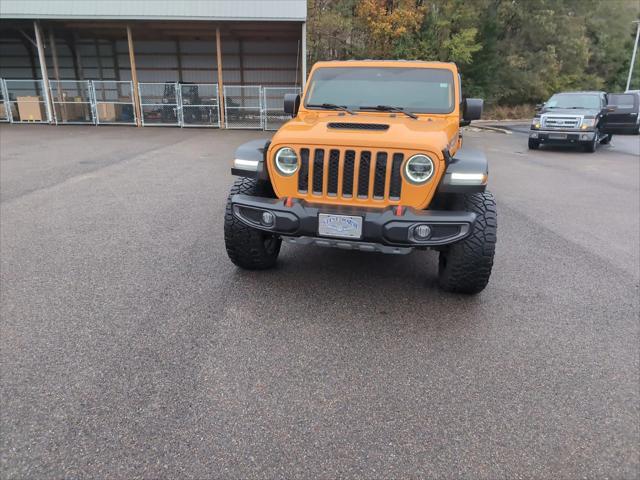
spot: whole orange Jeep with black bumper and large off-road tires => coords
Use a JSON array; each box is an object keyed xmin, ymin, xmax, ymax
[{"xmin": 224, "ymin": 60, "xmax": 497, "ymax": 293}]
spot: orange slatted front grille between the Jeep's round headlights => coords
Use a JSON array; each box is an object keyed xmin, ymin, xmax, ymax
[{"xmin": 298, "ymin": 148, "xmax": 404, "ymax": 202}]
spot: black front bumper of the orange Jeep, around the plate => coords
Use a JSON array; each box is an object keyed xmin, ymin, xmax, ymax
[{"xmin": 231, "ymin": 195, "xmax": 476, "ymax": 253}]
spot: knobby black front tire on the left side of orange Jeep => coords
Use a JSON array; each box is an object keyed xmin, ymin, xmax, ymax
[{"xmin": 224, "ymin": 177, "xmax": 282, "ymax": 270}]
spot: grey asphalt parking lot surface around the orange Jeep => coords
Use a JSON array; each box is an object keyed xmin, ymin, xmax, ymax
[{"xmin": 0, "ymin": 125, "xmax": 640, "ymax": 479}]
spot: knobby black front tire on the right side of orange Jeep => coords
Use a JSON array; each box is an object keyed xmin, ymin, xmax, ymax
[{"xmin": 438, "ymin": 192, "xmax": 498, "ymax": 294}]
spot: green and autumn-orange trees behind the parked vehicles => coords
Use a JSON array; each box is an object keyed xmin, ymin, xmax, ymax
[{"xmin": 308, "ymin": 0, "xmax": 640, "ymax": 105}]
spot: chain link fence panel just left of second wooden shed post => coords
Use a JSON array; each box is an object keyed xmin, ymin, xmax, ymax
[{"xmin": 91, "ymin": 80, "xmax": 136, "ymax": 125}]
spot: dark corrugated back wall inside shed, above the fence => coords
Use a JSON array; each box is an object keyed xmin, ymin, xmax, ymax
[{"xmin": 0, "ymin": 37, "xmax": 301, "ymax": 86}]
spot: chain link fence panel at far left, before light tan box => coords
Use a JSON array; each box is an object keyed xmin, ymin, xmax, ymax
[{"xmin": 4, "ymin": 80, "xmax": 51, "ymax": 123}]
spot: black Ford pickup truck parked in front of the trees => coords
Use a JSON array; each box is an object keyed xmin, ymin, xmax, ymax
[{"xmin": 529, "ymin": 92, "xmax": 612, "ymax": 152}]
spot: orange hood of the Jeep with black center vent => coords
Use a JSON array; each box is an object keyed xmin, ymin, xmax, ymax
[{"xmin": 272, "ymin": 112, "xmax": 459, "ymax": 156}]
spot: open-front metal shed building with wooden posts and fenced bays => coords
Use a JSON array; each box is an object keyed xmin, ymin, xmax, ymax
[{"xmin": 0, "ymin": 0, "xmax": 307, "ymax": 129}]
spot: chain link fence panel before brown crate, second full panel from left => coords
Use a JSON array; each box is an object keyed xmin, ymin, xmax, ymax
[{"xmin": 49, "ymin": 80, "xmax": 95, "ymax": 125}]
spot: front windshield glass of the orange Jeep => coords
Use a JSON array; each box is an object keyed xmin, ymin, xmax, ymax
[{"xmin": 304, "ymin": 67, "xmax": 455, "ymax": 113}]
